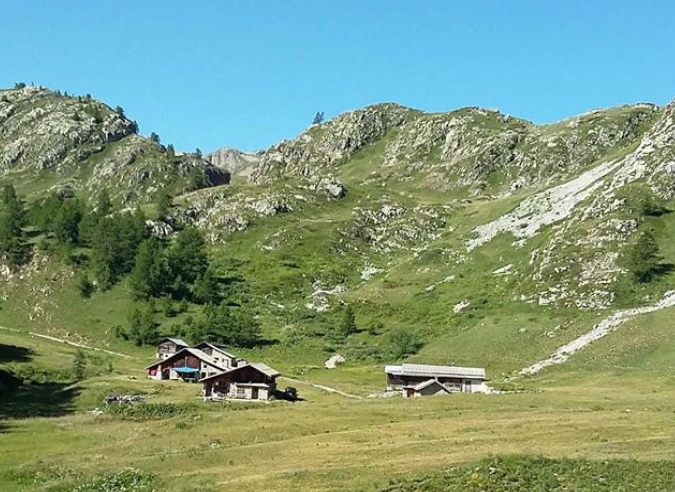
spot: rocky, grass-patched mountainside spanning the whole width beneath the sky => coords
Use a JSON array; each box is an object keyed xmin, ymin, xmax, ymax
[{"xmin": 0, "ymin": 83, "xmax": 675, "ymax": 380}]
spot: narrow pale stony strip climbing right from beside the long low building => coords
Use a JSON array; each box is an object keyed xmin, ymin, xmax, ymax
[{"xmin": 520, "ymin": 290, "xmax": 675, "ymax": 375}]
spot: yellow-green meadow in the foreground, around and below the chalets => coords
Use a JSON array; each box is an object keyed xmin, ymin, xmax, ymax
[{"xmin": 0, "ymin": 313, "xmax": 675, "ymax": 492}]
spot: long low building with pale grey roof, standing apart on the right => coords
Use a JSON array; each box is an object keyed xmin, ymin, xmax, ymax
[{"xmin": 384, "ymin": 364, "xmax": 488, "ymax": 398}]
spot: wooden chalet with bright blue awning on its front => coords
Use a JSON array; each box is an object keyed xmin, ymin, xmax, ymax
[{"xmin": 147, "ymin": 347, "xmax": 228, "ymax": 382}]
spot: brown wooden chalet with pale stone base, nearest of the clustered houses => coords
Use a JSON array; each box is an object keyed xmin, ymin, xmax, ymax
[{"xmin": 199, "ymin": 362, "xmax": 281, "ymax": 400}]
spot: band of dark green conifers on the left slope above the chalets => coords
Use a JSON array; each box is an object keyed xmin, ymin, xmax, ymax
[{"xmin": 0, "ymin": 185, "xmax": 260, "ymax": 347}]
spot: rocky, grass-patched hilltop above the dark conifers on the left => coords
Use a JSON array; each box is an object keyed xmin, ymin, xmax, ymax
[{"xmin": 0, "ymin": 87, "xmax": 229, "ymax": 204}]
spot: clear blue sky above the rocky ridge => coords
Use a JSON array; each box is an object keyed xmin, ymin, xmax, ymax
[{"xmin": 0, "ymin": 0, "xmax": 675, "ymax": 152}]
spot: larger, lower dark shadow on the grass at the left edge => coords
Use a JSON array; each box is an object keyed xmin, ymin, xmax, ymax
[{"xmin": 0, "ymin": 369, "xmax": 80, "ymax": 422}]
